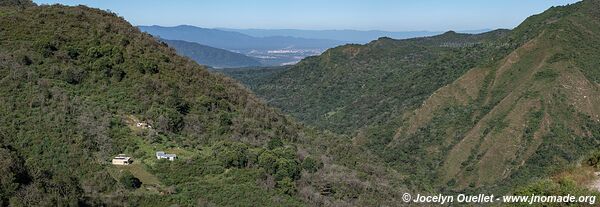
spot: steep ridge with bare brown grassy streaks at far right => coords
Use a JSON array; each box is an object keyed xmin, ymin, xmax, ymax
[{"xmin": 387, "ymin": 1, "xmax": 600, "ymax": 190}]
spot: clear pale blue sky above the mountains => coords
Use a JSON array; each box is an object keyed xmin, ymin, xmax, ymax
[{"xmin": 34, "ymin": 0, "xmax": 577, "ymax": 31}]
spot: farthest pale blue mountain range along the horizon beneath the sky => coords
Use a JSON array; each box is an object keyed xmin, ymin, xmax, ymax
[{"xmin": 217, "ymin": 28, "xmax": 490, "ymax": 44}]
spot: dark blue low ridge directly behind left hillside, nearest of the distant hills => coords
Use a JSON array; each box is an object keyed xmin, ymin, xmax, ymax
[{"xmin": 161, "ymin": 39, "xmax": 262, "ymax": 68}]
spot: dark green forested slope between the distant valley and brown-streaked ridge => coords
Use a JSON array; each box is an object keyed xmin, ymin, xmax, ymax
[{"xmin": 224, "ymin": 30, "xmax": 506, "ymax": 134}]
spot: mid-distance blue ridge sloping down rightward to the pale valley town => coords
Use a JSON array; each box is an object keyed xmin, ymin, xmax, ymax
[{"xmin": 139, "ymin": 25, "xmax": 344, "ymax": 51}]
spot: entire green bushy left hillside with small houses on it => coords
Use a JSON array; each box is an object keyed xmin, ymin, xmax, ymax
[{"xmin": 0, "ymin": 1, "xmax": 404, "ymax": 206}]
